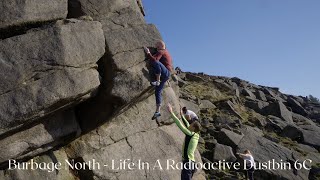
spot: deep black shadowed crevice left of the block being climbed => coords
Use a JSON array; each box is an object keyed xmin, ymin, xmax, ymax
[{"xmin": 76, "ymin": 41, "xmax": 152, "ymax": 133}]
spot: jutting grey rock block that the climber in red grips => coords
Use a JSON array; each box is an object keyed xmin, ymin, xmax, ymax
[{"xmin": 106, "ymin": 25, "xmax": 161, "ymax": 104}]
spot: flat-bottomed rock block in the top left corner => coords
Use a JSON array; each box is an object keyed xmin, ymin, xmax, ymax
[{"xmin": 0, "ymin": 0, "xmax": 68, "ymax": 29}]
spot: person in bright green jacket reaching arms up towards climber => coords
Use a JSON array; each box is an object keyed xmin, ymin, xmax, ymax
[{"xmin": 167, "ymin": 104, "xmax": 201, "ymax": 180}]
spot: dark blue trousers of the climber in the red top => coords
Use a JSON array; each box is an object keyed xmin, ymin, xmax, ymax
[{"xmin": 151, "ymin": 61, "xmax": 170, "ymax": 105}]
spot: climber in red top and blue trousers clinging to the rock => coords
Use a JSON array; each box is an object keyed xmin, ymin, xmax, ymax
[{"xmin": 144, "ymin": 41, "xmax": 172, "ymax": 119}]
